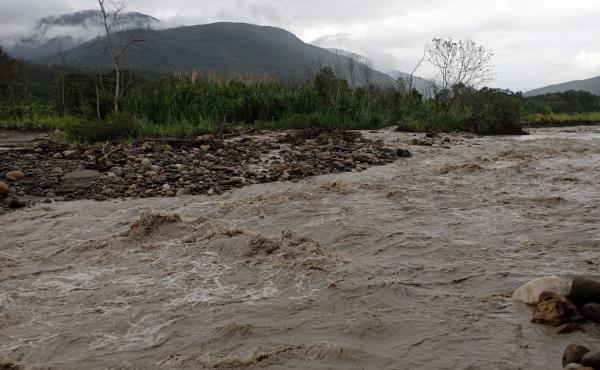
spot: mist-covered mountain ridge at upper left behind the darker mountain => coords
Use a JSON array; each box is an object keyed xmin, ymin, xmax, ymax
[{"xmin": 4, "ymin": 10, "xmax": 160, "ymax": 60}]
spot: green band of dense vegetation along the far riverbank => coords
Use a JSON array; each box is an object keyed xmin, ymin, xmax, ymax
[{"xmin": 0, "ymin": 47, "xmax": 600, "ymax": 140}]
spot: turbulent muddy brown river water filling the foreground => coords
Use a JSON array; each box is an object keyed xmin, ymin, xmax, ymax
[{"xmin": 0, "ymin": 127, "xmax": 600, "ymax": 370}]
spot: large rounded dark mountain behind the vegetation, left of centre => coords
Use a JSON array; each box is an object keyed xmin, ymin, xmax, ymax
[{"xmin": 36, "ymin": 22, "xmax": 395, "ymax": 86}]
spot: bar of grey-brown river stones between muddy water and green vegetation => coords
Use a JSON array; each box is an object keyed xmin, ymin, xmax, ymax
[{"xmin": 0, "ymin": 129, "xmax": 410, "ymax": 212}]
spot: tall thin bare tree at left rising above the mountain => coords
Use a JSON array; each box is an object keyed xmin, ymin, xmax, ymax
[{"xmin": 98, "ymin": 0, "xmax": 144, "ymax": 112}]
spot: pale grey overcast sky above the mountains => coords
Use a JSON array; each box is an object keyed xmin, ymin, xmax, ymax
[{"xmin": 0, "ymin": 0, "xmax": 600, "ymax": 91}]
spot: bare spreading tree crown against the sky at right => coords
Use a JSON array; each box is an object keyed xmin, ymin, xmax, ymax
[{"xmin": 425, "ymin": 38, "xmax": 493, "ymax": 98}]
